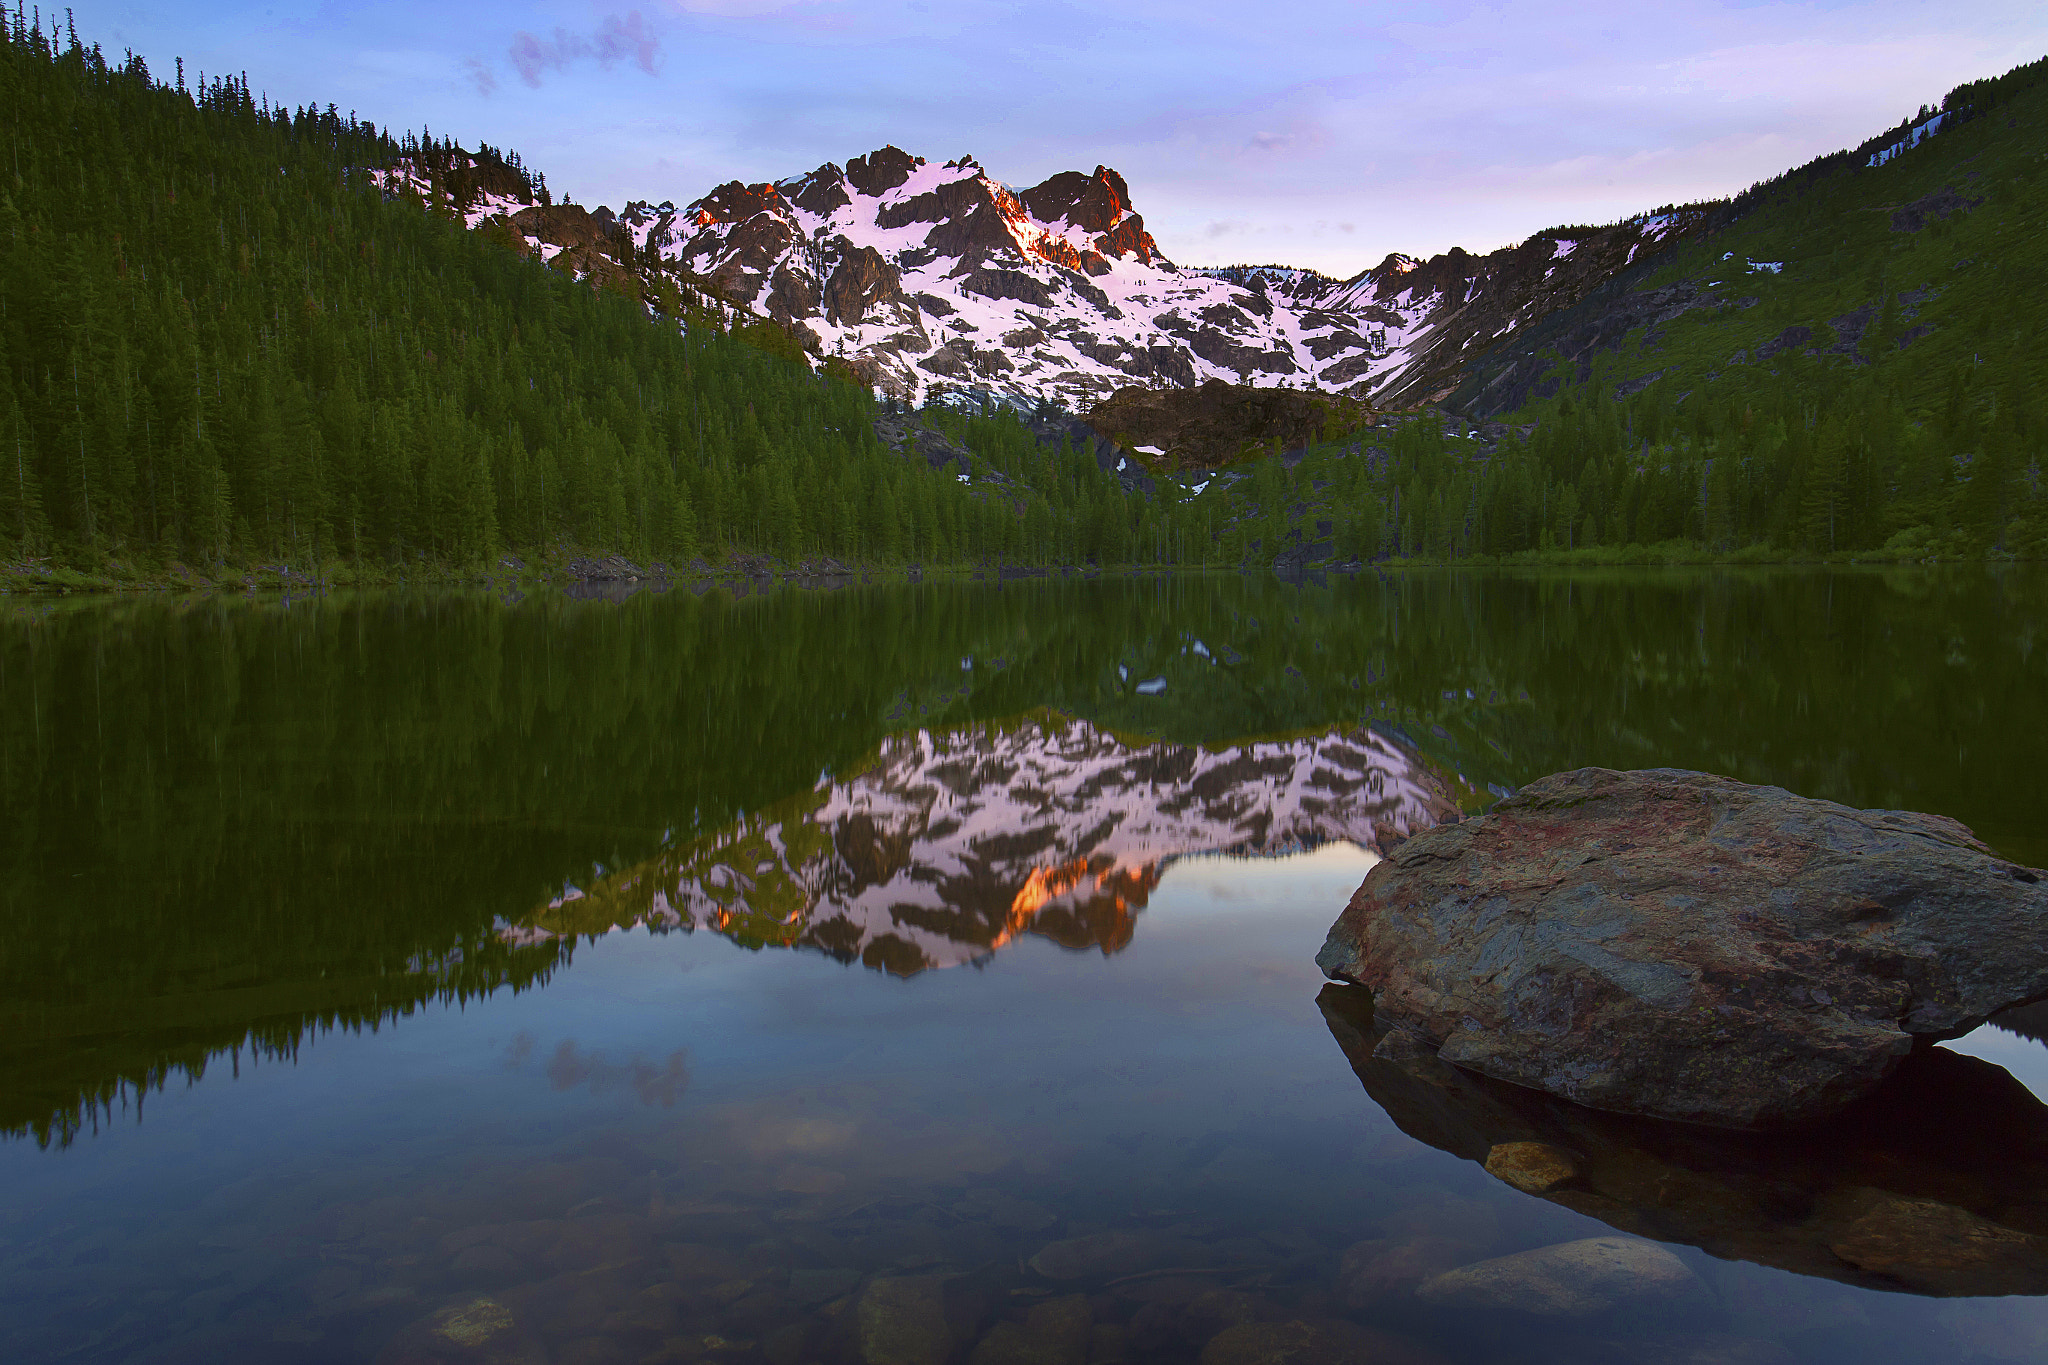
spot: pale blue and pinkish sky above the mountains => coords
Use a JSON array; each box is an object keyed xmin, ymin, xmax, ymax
[{"xmin": 78, "ymin": 0, "xmax": 2048, "ymax": 274}]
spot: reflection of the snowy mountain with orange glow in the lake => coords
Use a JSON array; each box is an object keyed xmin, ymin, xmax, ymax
[{"xmin": 502, "ymin": 714, "xmax": 1458, "ymax": 976}]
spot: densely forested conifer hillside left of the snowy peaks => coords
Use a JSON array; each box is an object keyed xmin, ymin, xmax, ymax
[{"xmin": 0, "ymin": 14, "xmax": 1196, "ymax": 579}]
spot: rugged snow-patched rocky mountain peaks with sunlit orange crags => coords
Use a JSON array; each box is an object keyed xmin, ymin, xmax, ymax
[{"xmin": 569, "ymin": 147, "xmax": 1710, "ymax": 409}]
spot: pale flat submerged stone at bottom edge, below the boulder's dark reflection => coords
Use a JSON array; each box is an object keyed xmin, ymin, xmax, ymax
[{"xmin": 1415, "ymin": 1236, "xmax": 1710, "ymax": 1318}]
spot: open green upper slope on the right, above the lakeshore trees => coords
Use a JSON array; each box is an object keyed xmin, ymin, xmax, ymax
[{"xmin": 1454, "ymin": 61, "xmax": 2048, "ymax": 427}]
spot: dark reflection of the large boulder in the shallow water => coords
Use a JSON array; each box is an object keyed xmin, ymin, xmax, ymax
[{"xmin": 1317, "ymin": 984, "xmax": 2048, "ymax": 1297}]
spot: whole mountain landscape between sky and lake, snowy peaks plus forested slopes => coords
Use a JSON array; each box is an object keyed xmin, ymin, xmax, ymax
[{"xmin": 0, "ymin": 12, "xmax": 2048, "ymax": 591}]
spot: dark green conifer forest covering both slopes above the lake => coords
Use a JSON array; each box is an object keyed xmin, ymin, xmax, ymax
[{"xmin": 0, "ymin": 12, "xmax": 2048, "ymax": 581}]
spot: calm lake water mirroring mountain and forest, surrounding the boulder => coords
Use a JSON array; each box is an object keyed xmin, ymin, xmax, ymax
[{"xmin": 0, "ymin": 569, "xmax": 2048, "ymax": 1365}]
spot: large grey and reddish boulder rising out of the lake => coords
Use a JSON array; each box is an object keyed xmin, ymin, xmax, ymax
[{"xmin": 1317, "ymin": 767, "xmax": 2048, "ymax": 1128}]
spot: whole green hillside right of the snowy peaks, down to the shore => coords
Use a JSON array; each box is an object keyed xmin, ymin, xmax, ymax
[{"xmin": 1196, "ymin": 61, "xmax": 2048, "ymax": 561}]
